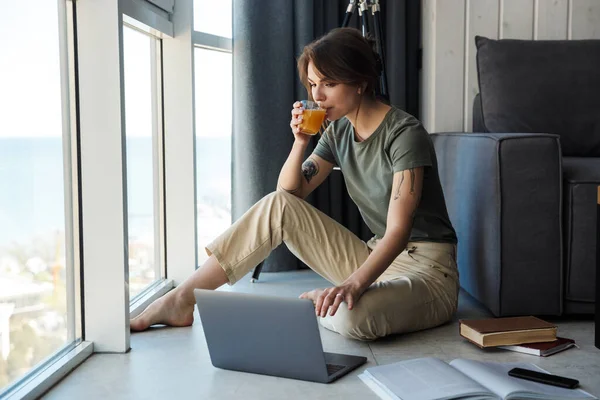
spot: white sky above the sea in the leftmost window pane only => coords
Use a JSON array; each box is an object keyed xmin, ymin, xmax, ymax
[{"xmin": 0, "ymin": 0, "xmax": 62, "ymax": 137}]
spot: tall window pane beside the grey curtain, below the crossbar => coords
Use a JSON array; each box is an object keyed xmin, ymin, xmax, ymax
[{"xmin": 194, "ymin": 48, "xmax": 232, "ymax": 264}]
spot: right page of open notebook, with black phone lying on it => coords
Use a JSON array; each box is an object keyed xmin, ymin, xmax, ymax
[{"xmin": 450, "ymin": 359, "xmax": 596, "ymax": 399}]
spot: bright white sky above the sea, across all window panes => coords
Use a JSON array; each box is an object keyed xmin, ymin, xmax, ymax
[{"xmin": 0, "ymin": 0, "xmax": 231, "ymax": 138}]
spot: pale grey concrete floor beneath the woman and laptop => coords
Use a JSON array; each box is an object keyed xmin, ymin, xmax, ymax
[{"xmin": 43, "ymin": 270, "xmax": 600, "ymax": 400}]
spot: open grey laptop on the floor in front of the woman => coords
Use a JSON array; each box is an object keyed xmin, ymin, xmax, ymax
[{"xmin": 194, "ymin": 289, "xmax": 367, "ymax": 383}]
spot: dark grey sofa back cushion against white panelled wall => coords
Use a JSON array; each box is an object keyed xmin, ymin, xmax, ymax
[{"xmin": 475, "ymin": 36, "xmax": 600, "ymax": 157}]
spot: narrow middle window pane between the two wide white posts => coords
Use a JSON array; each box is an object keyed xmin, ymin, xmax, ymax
[{"xmin": 123, "ymin": 26, "xmax": 162, "ymax": 299}]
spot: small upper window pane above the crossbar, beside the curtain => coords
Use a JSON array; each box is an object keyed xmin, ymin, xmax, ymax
[{"xmin": 194, "ymin": 0, "xmax": 231, "ymax": 38}]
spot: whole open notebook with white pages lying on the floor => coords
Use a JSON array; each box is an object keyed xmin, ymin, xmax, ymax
[{"xmin": 359, "ymin": 358, "xmax": 597, "ymax": 400}]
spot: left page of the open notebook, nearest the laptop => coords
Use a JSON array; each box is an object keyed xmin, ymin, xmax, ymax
[{"xmin": 365, "ymin": 358, "xmax": 497, "ymax": 400}]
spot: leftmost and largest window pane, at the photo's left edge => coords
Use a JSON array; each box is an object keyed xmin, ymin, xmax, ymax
[{"xmin": 0, "ymin": 0, "xmax": 75, "ymax": 392}]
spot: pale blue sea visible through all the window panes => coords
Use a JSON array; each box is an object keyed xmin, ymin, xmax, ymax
[{"xmin": 0, "ymin": 136, "xmax": 231, "ymax": 248}]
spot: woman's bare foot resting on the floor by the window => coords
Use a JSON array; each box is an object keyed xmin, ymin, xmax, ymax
[{"xmin": 129, "ymin": 290, "xmax": 194, "ymax": 332}]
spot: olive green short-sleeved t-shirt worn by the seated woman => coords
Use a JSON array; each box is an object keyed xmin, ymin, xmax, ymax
[{"xmin": 314, "ymin": 107, "xmax": 457, "ymax": 243}]
